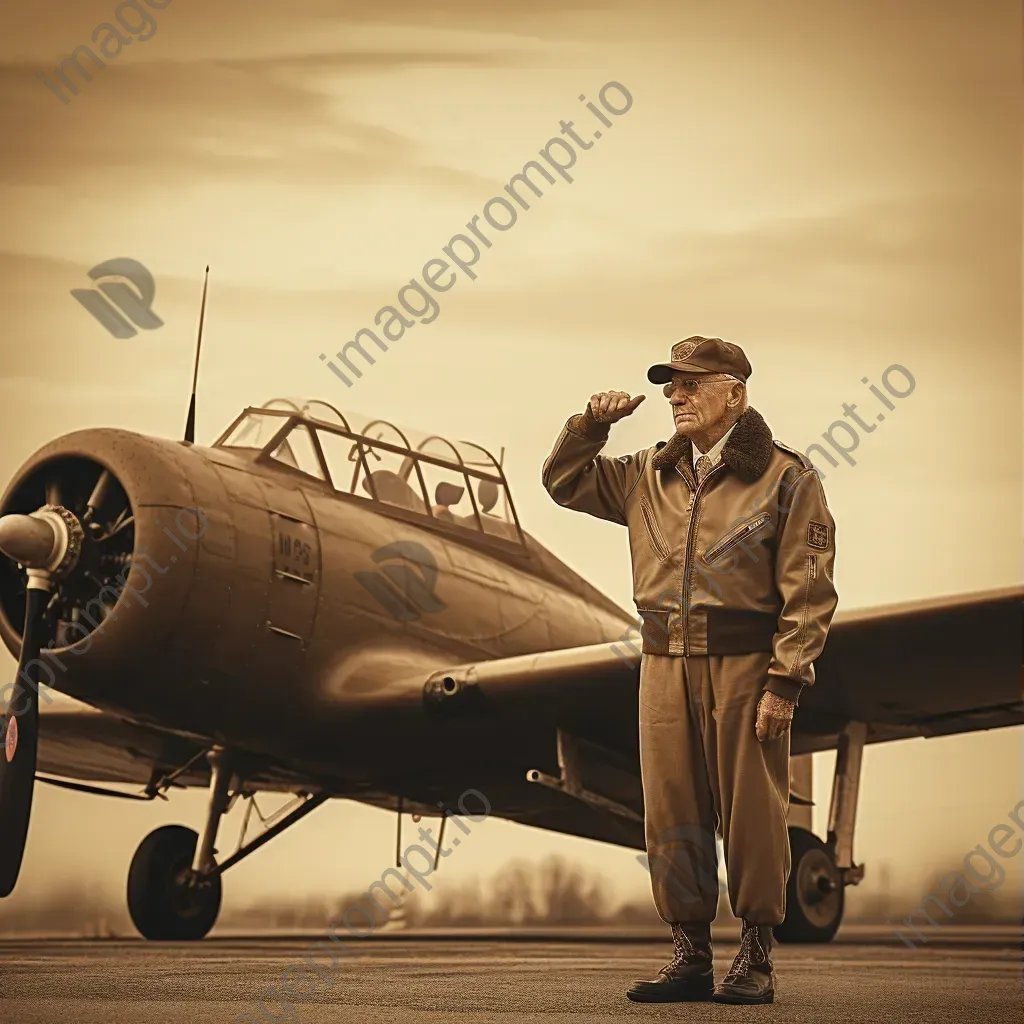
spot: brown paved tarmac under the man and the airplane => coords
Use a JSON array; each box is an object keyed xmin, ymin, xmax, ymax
[{"xmin": 0, "ymin": 926, "xmax": 1024, "ymax": 1024}]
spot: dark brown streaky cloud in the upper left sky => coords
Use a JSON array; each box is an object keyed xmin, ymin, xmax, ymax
[{"xmin": 0, "ymin": 44, "xmax": 528, "ymax": 187}]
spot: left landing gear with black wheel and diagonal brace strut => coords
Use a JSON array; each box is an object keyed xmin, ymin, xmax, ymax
[{"xmin": 128, "ymin": 746, "xmax": 331, "ymax": 941}]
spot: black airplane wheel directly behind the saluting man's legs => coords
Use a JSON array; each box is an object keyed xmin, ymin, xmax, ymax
[{"xmin": 772, "ymin": 825, "xmax": 843, "ymax": 942}]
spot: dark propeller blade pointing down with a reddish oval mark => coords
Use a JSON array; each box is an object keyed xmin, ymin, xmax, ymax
[{"xmin": 0, "ymin": 588, "xmax": 50, "ymax": 897}]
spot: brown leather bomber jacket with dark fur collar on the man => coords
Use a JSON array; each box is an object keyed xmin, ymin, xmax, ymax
[{"xmin": 543, "ymin": 407, "xmax": 838, "ymax": 700}]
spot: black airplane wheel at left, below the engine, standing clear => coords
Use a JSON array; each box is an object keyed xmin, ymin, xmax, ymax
[{"xmin": 128, "ymin": 825, "xmax": 220, "ymax": 941}]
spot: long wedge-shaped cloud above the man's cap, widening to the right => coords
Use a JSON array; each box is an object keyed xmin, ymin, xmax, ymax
[{"xmin": 421, "ymin": 186, "xmax": 1020, "ymax": 338}]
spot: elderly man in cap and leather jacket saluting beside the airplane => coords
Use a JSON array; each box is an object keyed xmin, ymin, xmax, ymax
[{"xmin": 544, "ymin": 337, "xmax": 837, "ymax": 1002}]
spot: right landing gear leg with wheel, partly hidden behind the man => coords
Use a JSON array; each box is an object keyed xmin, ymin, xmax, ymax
[{"xmin": 773, "ymin": 722, "xmax": 867, "ymax": 942}]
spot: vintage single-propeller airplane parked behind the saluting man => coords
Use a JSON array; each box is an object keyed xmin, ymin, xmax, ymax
[{"xmin": 0, "ymin": 399, "xmax": 1024, "ymax": 941}]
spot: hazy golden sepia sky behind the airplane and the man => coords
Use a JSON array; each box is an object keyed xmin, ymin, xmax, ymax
[{"xmin": 0, "ymin": 0, "xmax": 1024, "ymax": 924}]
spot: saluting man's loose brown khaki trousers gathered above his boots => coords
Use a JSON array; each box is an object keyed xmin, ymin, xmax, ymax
[{"xmin": 640, "ymin": 652, "xmax": 791, "ymax": 925}]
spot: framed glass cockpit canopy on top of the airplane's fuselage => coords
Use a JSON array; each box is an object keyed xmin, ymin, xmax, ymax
[{"xmin": 214, "ymin": 398, "xmax": 525, "ymax": 544}]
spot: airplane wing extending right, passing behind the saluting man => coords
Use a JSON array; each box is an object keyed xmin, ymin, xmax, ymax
[{"xmin": 426, "ymin": 587, "xmax": 1024, "ymax": 754}]
